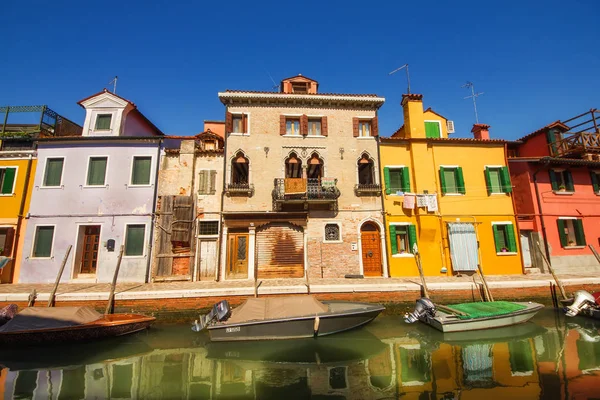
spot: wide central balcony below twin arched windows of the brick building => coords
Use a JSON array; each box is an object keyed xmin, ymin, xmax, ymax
[{"xmin": 273, "ymin": 178, "xmax": 341, "ymax": 211}]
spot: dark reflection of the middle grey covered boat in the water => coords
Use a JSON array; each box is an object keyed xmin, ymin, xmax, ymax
[{"xmin": 206, "ymin": 331, "xmax": 388, "ymax": 364}]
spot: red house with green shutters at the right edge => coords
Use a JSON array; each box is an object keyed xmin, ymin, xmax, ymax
[{"xmin": 508, "ymin": 109, "xmax": 600, "ymax": 272}]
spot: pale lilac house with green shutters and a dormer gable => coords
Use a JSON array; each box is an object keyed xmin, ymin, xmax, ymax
[{"xmin": 19, "ymin": 90, "xmax": 163, "ymax": 283}]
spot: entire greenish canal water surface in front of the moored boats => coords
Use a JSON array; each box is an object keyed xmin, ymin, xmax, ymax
[{"xmin": 0, "ymin": 307, "xmax": 600, "ymax": 400}]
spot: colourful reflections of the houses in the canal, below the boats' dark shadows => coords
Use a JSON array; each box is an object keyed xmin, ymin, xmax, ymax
[{"xmin": 0, "ymin": 327, "xmax": 600, "ymax": 400}]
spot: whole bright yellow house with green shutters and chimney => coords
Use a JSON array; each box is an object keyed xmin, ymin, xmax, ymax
[{"xmin": 380, "ymin": 94, "xmax": 523, "ymax": 277}]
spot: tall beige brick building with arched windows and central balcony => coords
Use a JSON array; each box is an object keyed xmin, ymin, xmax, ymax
[{"xmin": 219, "ymin": 75, "xmax": 387, "ymax": 279}]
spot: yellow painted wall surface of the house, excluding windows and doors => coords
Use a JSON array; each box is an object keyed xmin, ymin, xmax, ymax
[{"xmin": 380, "ymin": 100, "xmax": 523, "ymax": 277}]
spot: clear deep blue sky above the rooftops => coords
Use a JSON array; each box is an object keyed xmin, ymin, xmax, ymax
[{"xmin": 0, "ymin": 0, "xmax": 600, "ymax": 139}]
